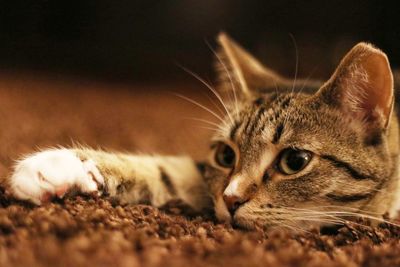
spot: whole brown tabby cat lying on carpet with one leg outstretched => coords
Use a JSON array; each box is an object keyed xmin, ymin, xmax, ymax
[{"xmin": 8, "ymin": 33, "xmax": 400, "ymax": 230}]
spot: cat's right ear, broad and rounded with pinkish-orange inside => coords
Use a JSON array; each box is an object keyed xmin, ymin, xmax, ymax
[{"xmin": 317, "ymin": 43, "xmax": 394, "ymax": 128}]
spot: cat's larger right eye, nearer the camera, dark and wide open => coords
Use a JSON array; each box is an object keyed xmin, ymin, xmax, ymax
[{"xmin": 277, "ymin": 148, "xmax": 312, "ymax": 175}]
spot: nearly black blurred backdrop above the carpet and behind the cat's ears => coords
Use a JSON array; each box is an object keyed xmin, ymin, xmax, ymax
[{"xmin": 0, "ymin": 0, "xmax": 400, "ymax": 81}]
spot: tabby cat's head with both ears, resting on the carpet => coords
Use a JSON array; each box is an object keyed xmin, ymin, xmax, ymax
[{"xmin": 205, "ymin": 34, "xmax": 398, "ymax": 228}]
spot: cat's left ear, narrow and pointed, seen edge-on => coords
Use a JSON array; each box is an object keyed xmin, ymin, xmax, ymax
[{"xmin": 216, "ymin": 33, "xmax": 288, "ymax": 96}]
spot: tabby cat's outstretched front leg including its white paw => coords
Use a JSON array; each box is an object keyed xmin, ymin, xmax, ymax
[{"xmin": 9, "ymin": 148, "xmax": 210, "ymax": 213}]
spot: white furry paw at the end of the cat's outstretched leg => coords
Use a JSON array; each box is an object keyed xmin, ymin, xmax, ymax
[{"xmin": 10, "ymin": 149, "xmax": 104, "ymax": 205}]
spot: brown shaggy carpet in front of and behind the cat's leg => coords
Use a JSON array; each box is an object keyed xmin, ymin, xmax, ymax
[{"xmin": 0, "ymin": 74, "xmax": 400, "ymax": 267}]
